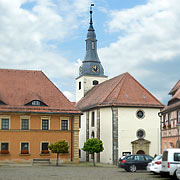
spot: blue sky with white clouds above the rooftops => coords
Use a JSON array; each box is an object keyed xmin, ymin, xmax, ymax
[{"xmin": 0, "ymin": 0, "xmax": 180, "ymax": 104}]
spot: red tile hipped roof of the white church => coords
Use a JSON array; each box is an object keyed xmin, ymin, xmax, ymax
[{"xmin": 76, "ymin": 73, "xmax": 164, "ymax": 110}]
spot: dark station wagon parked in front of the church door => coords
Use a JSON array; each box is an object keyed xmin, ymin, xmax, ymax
[{"xmin": 119, "ymin": 154, "xmax": 153, "ymax": 172}]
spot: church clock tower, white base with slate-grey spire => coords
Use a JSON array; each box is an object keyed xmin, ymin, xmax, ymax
[{"xmin": 76, "ymin": 4, "xmax": 107, "ymax": 102}]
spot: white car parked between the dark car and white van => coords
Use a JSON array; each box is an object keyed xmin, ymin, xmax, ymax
[{"xmin": 147, "ymin": 155, "xmax": 162, "ymax": 174}]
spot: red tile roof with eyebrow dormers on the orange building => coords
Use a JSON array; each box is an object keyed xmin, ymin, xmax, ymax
[{"xmin": 0, "ymin": 69, "xmax": 80, "ymax": 113}]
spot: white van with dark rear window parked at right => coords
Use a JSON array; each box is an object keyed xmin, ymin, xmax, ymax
[{"xmin": 160, "ymin": 148, "xmax": 180, "ymax": 179}]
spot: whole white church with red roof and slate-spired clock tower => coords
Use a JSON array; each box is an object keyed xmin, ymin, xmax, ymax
[{"xmin": 76, "ymin": 5, "xmax": 163, "ymax": 164}]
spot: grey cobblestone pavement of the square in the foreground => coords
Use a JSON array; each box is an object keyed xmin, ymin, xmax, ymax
[{"xmin": 0, "ymin": 165, "xmax": 169, "ymax": 180}]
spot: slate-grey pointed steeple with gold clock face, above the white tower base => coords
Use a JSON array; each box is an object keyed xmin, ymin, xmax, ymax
[{"xmin": 79, "ymin": 4, "xmax": 104, "ymax": 76}]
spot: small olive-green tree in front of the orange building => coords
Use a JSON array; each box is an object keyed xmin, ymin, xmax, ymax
[{"xmin": 48, "ymin": 140, "xmax": 69, "ymax": 166}]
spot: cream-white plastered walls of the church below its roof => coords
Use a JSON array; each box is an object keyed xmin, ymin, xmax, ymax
[{"xmin": 80, "ymin": 107, "xmax": 160, "ymax": 164}]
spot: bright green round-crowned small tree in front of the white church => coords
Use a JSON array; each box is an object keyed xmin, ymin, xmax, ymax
[{"xmin": 82, "ymin": 138, "xmax": 104, "ymax": 166}]
